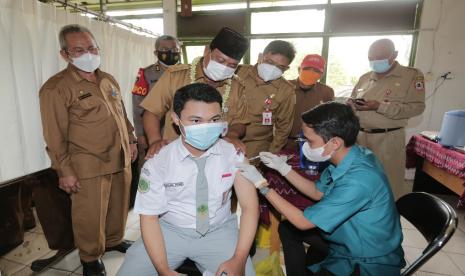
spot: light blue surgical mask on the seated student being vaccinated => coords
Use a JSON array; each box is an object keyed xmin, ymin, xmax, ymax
[{"xmin": 179, "ymin": 122, "xmax": 225, "ymax": 150}]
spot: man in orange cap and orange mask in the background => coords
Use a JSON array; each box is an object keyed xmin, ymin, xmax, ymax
[{"xmin": 286, "ymin": 54, "xmax": 334, "ymax": 151}]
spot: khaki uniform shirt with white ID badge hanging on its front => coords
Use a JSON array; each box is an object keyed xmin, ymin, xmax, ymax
[{"xmin": 237, "ymin": 65, "xmax": 295, "ymax": 157}]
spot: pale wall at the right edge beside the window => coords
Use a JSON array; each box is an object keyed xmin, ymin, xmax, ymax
[{"xmin": 407, "ymin": 0, "xmax": 465, "ymax": 139}]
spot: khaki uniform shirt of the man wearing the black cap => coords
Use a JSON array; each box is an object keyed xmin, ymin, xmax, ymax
[{"xmin": 141, "ymin": 60, "xmax": 247, "ymax": 140}]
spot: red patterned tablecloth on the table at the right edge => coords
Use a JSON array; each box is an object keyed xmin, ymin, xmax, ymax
[{"xmin": 406, "ymin": 135, "xmax": 465, "ymax": 208}]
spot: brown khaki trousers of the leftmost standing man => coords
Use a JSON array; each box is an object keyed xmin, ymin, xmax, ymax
[{"xmin": 71, "ymin": 166, "xmax": 131, "ymax": 262}]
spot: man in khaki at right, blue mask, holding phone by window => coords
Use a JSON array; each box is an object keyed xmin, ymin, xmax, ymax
[{"xmin": 348, "ymin": 39, "xmax": 425, "ymax": 198}]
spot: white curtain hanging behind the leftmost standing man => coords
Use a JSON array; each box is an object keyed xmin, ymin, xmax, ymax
[{"xmin": 0, "ymin": 0, "xmax": 155, "ymax": 183}]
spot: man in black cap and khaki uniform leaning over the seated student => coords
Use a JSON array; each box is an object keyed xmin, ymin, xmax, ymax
[{"xmin": 141, "ymin": 28, "xmax": 249, "ymax": 158}]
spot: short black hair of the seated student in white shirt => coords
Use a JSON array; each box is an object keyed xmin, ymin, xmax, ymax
[{"xmin": 173, "ymin": 83, "xmax": 223, "ymax": 117}]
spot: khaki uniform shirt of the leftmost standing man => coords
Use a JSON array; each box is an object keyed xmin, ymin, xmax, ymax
[{"xmin": 39, "ymin": 65, "xmax": 135, "ymax": 179}]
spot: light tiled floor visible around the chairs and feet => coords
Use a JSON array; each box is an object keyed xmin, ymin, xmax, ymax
[{"xmin": 0, "ymin": 194, "xmax": 465, "ymax": 276}]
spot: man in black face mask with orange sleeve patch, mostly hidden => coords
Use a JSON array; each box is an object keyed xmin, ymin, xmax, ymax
[{"xmin": 130, "ymin": 35, "xmax": 181, "ymax": 206}]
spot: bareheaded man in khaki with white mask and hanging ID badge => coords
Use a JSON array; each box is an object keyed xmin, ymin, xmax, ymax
[{"xmin": 237, "ymin": 40, "xmax": 295, "ymax": 158}]
